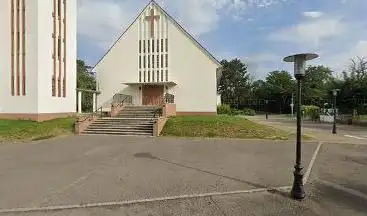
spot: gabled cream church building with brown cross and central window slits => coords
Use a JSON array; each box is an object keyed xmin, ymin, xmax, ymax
[{"xmin": 93, "ymin": 1, "xmax": 221, "ymax": 115}]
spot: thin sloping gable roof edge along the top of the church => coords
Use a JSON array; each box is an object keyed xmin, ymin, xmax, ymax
[{"xmin": 92, "ymin": 0, "xmax": 222, "ymax": 70}]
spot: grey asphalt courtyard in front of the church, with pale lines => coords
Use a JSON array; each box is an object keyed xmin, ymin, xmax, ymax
[{"xmin": 0, "ymin": 136, "xmax": 367, "ymax": 216}]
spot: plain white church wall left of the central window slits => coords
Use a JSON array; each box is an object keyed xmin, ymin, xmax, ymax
[{"xmin": 94, "ymin": 23, "xmax": 139, "ymax": 107}]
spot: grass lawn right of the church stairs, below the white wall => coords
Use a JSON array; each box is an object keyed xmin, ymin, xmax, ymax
[{"xmin": 162, "ymin": 115, "xmax": 291, "ymax": 140}]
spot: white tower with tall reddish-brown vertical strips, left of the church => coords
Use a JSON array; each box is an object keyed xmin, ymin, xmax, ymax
[{"xmin": 0, "ymin": 0, "xmax": 77, "ymax": 121}]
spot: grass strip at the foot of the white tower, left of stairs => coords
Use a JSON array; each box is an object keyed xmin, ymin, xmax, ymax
[{"xmin": 0, "ymin": 117, "xmax": 75, "ymax": 141}]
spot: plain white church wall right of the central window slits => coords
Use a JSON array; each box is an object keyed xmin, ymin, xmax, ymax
[{"xmin": 169, "ymin": 23, "xmax": 218, "ymax": 112}]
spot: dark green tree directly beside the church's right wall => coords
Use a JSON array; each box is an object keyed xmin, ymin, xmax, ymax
[{"xmin": 218, "ymin": 58, "xmax": 250, "ymax": 107}]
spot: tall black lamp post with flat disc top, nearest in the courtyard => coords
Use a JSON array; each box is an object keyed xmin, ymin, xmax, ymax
[{"xmin": 284, "ymin": 53, "xmax": 318, "ymax": 200}]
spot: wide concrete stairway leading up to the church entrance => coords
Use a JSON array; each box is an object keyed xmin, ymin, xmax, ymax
[{"xmin": 83, "ymin": 106, "xmax": 157, "ymax": 136}]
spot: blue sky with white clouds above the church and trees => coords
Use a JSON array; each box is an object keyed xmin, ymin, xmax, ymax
[{"xmin": 78, "ymin": 0, "xmax": 367, "ymax": 79}]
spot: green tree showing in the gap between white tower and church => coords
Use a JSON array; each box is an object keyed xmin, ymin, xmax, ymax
[{"xmin": 77, "ymin": 60, "xmax": 96, "ymax": 111}]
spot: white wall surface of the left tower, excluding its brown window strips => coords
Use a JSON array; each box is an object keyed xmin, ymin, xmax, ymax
[{"xmin": 0, "ymin": 0, "xmax": 77, "ymax": 114}]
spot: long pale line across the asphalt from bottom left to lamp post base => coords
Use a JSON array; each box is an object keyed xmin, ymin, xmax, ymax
[{"xmin": 0, "ymin": 186, "xmax": 292, "ymax": 213}]
